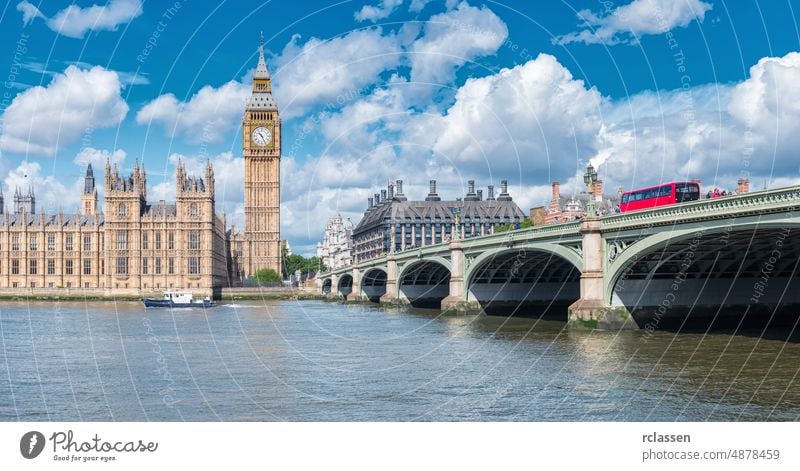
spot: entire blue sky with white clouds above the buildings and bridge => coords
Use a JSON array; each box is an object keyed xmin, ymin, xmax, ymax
[{"xmin": 0, "ymin": 0, "xmax": 800, "ymax": 253}]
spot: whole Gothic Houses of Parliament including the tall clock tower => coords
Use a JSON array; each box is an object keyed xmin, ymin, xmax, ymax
[{"xmin": 0, "ymin": 36, "xmax": 281, "ymax": 295}]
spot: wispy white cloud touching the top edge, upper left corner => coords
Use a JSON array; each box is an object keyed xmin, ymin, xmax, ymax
[{"xmin": 17, "ymin": 0, "xmax": 142, "ymax": 38}]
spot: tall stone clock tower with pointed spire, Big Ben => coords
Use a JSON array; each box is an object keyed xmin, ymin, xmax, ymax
[{"xmin": 242, "ymin": 33, "xmax": 281, "ymax": 276}]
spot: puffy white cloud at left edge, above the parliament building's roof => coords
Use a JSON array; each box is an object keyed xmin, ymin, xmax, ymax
[{"xmin": 0, "ymin": 65, "xmax": 128, "ymax": 156}]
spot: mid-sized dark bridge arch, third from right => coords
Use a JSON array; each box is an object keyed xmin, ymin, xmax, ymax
[{"xmin": 397, "ymin": 257, "xmax": 450, "ymax": 309}]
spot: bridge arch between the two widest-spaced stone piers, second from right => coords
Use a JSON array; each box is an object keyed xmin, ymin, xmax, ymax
[{"xmin": 464, "ymin": 244, "xmax": 582, "ymax": 320}]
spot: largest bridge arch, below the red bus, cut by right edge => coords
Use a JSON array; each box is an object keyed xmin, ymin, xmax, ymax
[{"xmin": 605, "ymin": 222, "xmax": 800, "ymax": 329}]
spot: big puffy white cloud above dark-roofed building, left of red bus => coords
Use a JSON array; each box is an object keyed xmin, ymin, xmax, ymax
[{"xmin": 433, "ymin": 54, "xmax": 602, "ymax": 177}]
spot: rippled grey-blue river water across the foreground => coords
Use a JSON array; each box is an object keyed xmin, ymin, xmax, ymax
[{"xmin": 0, "ymin": 301, "xmax": 800, "ymax": 421}]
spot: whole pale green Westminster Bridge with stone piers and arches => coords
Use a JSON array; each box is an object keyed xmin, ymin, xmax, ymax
[{"xmin": 321, "ymin": 186, "xmax": 800, "ymax": 330}]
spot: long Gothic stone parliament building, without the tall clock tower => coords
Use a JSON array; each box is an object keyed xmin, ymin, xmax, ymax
[{"xmin": 0, "ymin": 162, "xmax": 227, "ymax": 294}]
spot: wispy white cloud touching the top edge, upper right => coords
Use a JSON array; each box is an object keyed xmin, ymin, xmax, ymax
[{"xmin": 554, "ymin": 0, "xmax": 712, "ymax": 45}]
